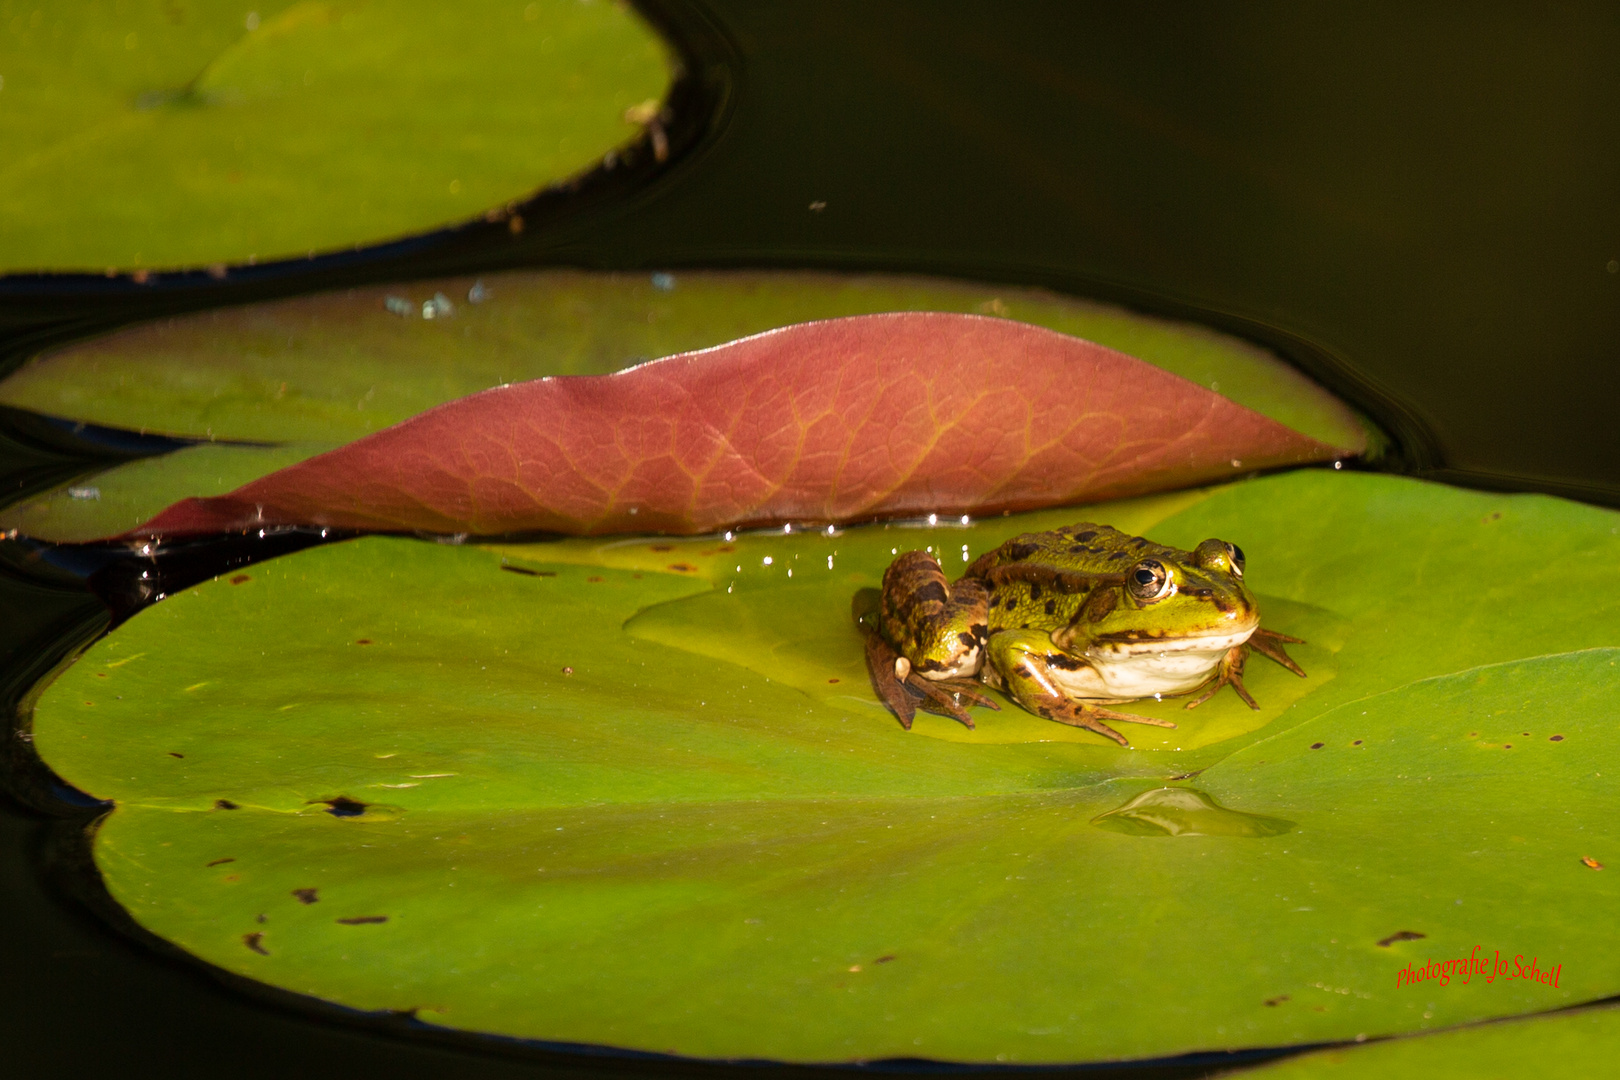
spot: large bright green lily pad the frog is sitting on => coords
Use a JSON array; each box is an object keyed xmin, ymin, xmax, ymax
[{"xmin": 25, "ymin": 470, "xmax": 1620, "ymax": 1062}]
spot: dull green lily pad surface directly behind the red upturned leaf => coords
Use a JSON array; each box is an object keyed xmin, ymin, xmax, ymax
[{"xmin": 0, "ymin": 275, "xmax": 1369, "ymax": 447}]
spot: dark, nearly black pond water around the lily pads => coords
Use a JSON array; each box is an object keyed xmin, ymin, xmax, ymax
[{"xmin": 0, "ymin": 0, "xmax": 1620, "ymax": 1077}]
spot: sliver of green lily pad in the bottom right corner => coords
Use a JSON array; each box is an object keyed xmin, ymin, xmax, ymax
[{"xmin": 1244, "ymin": 1009, "xmax": 1620, "ymax": 1080}]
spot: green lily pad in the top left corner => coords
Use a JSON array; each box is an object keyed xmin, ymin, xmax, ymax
[{"xmin": 0, "ymin": 0, "xmax": 672, "ymax": 272}]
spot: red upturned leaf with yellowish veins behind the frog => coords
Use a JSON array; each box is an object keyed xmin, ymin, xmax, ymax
[{"xmin": 133, "ymin": 313, "xmax": 1359, "ymax": 536}]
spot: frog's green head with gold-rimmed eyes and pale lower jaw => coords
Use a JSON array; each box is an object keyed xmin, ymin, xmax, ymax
[{"xmin": 1053, "ymin": 539, "xmax": 1260, "ymax": 654}]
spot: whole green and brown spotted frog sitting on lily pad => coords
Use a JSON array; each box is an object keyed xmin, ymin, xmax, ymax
[{"xmin": 859, "ymin": 523, "xmax": 1304, "ymax": 746}]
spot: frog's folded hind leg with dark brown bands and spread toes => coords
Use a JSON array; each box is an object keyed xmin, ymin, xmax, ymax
[{"xmin": 863, "ymin": 551, "xmax": 998, "ymax": 729}]
